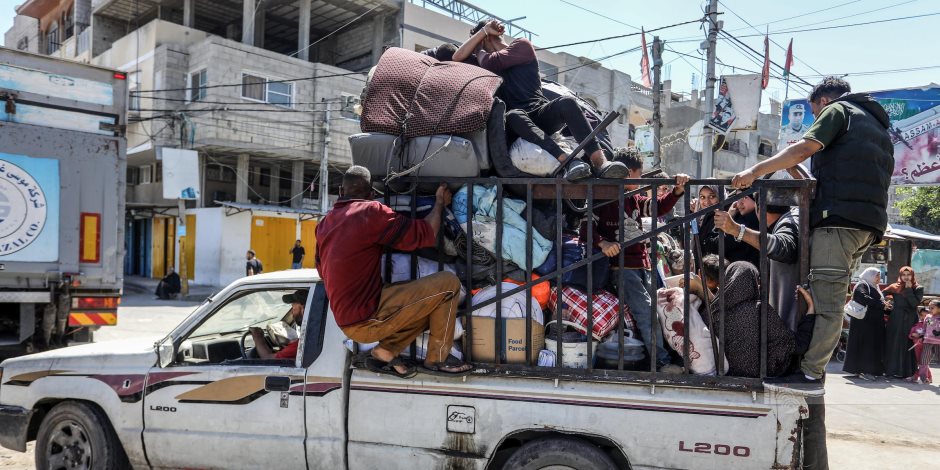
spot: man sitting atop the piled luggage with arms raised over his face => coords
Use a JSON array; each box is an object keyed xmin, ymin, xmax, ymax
[{"xmin": 453, "ymin": 20, "xmax": 629, "ymax": 181}]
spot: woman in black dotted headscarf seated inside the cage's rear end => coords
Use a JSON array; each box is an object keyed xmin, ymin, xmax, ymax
[{"xmin": 701, "ymin": 261, "xmax": 796, "ymax": 377}]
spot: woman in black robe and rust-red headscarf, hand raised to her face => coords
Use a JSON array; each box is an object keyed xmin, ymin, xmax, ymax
[{"xmin": 884, "ymin": 266, "xmax": 924, "ymax": 379}]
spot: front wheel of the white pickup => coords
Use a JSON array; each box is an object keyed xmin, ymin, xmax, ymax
[{"xmin": 35, "ymin": 401, "xmax": 131, "ymax": 470}]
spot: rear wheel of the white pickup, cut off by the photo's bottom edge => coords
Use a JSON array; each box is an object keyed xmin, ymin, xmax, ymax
[{"xmin": 503, "ymin": 437, "xmax": 617, "ymax": 470}]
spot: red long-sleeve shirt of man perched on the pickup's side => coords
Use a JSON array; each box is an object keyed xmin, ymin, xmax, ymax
[{"xmin": 316, "ymin": 199, "xmax": 437, "ymax": 326}]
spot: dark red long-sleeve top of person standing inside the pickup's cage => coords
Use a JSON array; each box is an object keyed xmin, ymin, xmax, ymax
[{"xmin": 581, "ymin": 191, "xmax": 680, "ymax": 269}]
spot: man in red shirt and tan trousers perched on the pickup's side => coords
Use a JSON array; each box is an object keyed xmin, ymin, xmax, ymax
[{"xmin": 316, "ymin": 165, "xmax": 473, "ymax": 378}]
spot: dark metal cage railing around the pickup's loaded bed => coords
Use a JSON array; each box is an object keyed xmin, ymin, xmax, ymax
[{"xmin": 374, "ymin": 173, "xmax": 815, "ymax": 390}]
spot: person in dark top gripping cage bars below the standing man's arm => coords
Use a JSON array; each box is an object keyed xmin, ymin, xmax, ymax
[{"xmin": 715, "ymin": 201, "xmax": 800, "ymax": 331}]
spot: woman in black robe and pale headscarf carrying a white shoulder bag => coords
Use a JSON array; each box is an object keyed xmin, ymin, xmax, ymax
[{"xmin": 842, "ymin": 268, "xmax": 887, "ymax": 380}]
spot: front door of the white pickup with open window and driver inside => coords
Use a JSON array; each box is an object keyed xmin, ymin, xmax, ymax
[{"xmin": 144, "ymin": 284, "xmax": 313, "ymax": 468}]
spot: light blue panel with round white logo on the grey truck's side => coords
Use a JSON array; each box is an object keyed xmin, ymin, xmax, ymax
[{"xmin": 0, "ymin": 152, "xmax": 59, "ymax": 262}]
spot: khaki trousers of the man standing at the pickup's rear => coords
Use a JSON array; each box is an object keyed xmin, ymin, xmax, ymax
[{"xmin": 800, "ymin": 227, "xmax": 877, "ymax": 379}]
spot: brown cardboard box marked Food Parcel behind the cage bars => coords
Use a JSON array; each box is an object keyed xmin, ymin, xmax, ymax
[{"xmin": 465, "ymin": 317, "xmax": 545, "ymax": 364}]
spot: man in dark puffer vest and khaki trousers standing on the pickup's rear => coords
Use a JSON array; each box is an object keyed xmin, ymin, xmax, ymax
[{"xmin": 732, "ymin": 77, "xmax": 894, "ymax": 396}]
